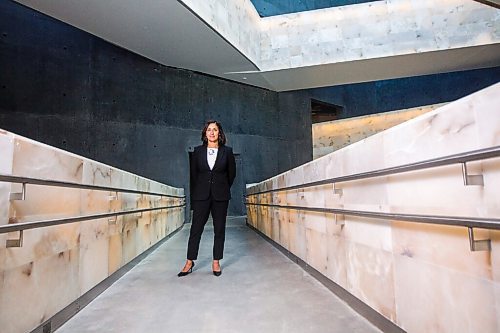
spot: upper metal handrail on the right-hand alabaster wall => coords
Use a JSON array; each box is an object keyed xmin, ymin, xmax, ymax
[{"xmin": 245, "ymin": 146, "xmax": 500, "ymax": 197}]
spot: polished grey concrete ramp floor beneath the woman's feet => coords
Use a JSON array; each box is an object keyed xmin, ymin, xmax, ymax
[{"xmin": 57, "ymin": 218, "xmax": 380, "ymax": 333}]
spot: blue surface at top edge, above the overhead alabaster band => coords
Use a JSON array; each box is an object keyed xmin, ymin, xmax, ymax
[{"xmin": 251, "ymin": 0, "xmax": 382, "ymax": 17}]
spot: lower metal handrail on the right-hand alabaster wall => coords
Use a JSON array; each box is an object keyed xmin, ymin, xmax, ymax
[{"xmin": 246, "ymin": 202, "xmax": 500, "ymax": 230}]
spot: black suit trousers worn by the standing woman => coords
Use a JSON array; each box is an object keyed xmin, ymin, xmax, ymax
[{"xmin": 187, "ymin": 195, "xmax": 229, "ymax": 260}]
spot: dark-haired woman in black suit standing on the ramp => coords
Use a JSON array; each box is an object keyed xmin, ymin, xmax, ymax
[{"xmin": 177, "ymin": 120, "xmax": 236, "ymax": 277}]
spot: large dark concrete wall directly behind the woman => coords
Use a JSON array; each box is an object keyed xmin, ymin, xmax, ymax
[{"xmin": 0, "ymin": 0, "xmax": 312, "ymax": 214}]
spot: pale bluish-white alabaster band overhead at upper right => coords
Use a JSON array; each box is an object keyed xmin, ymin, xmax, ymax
[{"xmin": 258, "ymin": 0, "xmax": 500, "ymax": 70}]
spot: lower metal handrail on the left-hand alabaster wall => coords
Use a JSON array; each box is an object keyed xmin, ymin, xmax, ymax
[{"xmin": 0, "ymin": 203, "xmax": 186, "ymax": 234}]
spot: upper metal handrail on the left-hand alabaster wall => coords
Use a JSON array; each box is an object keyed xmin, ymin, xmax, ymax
[{"xmin": 0, "ymin": 174, "xmax": 186, "ymax": 198}]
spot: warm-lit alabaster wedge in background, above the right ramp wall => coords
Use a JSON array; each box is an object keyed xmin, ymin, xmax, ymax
[{"xmin": 312, "ymin": 103, "xmax": 444, "ymax": 159}]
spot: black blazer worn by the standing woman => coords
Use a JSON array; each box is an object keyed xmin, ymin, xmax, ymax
[{"xmin": 190, "ymin": 145, "xmax": 236, "ymax": 201}]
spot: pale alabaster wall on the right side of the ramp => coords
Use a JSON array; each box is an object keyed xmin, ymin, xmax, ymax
[{"xmin": 247, "ymin": 84, "xmax": 500, "ymax": 333}]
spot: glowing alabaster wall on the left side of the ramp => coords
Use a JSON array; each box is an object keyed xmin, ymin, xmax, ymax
[{"xmin": 0, "ymin": 130, "xmax": 184, "ymax": 333}]
